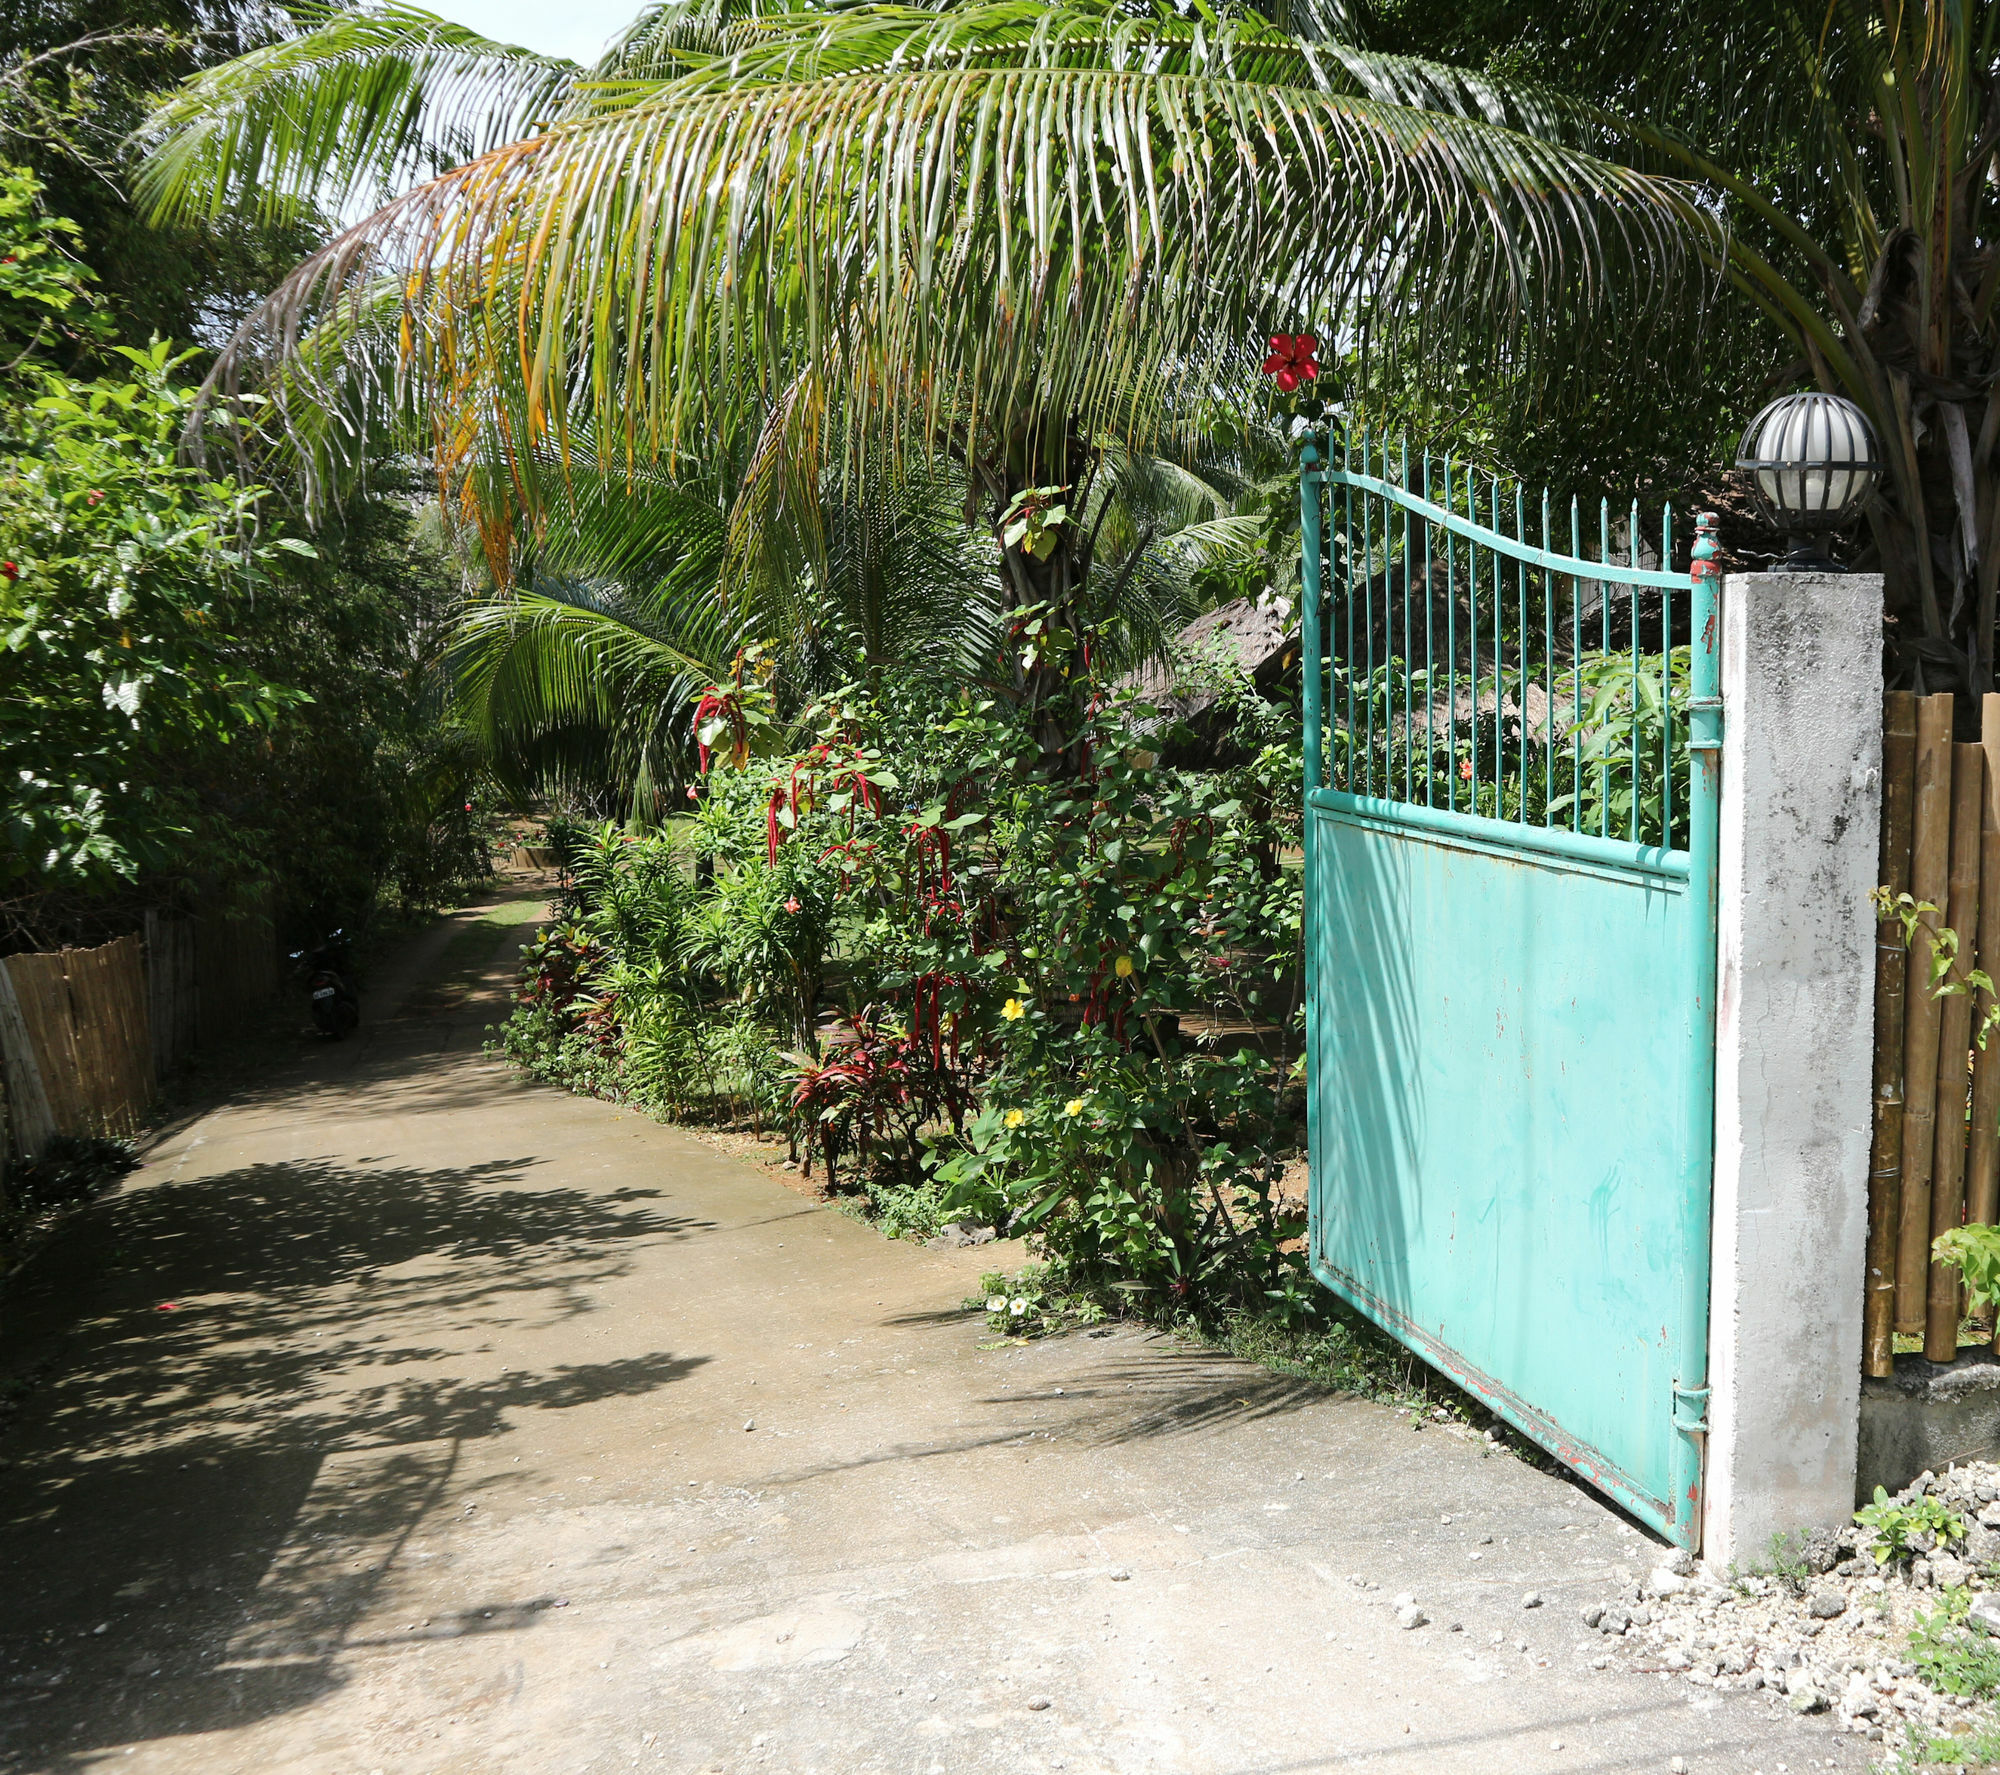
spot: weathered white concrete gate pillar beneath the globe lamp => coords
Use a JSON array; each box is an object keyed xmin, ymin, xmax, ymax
[{"xmin": 1702, "ymin": 574, "xmax": 1882, "ymax": 1569}]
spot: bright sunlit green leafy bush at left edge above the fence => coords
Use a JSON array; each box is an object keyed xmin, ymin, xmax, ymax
[{"xmin": 0, "ymin": 168, "xmax": 312, "ymax": 889}]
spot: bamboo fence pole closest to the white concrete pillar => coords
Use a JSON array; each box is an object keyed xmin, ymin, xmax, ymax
[{"xmin": 1862, "ymin": 690, "xmax": 1912, "ymax": 1375}]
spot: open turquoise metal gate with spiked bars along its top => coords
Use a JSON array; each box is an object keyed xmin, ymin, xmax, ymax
[{"xmin": 1300, "ymin": 440, "xmax": 1722, "ymax": 1545}]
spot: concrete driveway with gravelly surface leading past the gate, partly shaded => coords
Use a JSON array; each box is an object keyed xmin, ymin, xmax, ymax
[{"xmin": 0, "ymin": 895, "xmax": 1866, "ymax": 1775}]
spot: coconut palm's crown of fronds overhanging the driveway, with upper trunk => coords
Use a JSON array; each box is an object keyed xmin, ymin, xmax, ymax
[{"xmin": 144, "ymin": 0, "xmax": 1722, "ymax": 739}]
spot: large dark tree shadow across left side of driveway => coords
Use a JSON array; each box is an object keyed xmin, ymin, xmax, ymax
[{"xmin": 0, "ymin": 1159, "xmax": 708, "ymax": 1775}]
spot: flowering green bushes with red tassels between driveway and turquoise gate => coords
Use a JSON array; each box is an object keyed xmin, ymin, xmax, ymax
[{"xmin": 506, "ymin": 630, "xmax": 1312, "ymax": 1317}]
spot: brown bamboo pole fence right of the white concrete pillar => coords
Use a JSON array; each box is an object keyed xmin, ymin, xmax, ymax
[{"xmin": 1862, "ymin": 692, "xmax": 2000, "ymax": 1375}]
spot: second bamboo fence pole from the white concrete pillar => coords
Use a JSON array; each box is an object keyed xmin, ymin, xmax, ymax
[{"xmin": 1896, "ymin": 692, "xmax": 1952, "ymax": 1333}]
